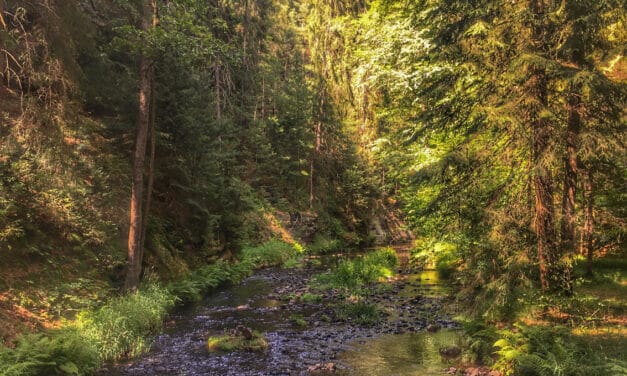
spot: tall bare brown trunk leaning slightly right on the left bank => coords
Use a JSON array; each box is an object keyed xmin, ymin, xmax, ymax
[{"xmin": 124, "ymin": 0, "xmax": 157, "ymax": 290}]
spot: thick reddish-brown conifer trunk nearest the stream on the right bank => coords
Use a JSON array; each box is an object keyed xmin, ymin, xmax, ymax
[{"xmin": 525, "ymin": 0, "xmax": 558, "ymax": 290}]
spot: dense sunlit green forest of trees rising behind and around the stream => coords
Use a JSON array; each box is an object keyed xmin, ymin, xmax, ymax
[{"xmin": 0, "ymin": 0, "xmax": 627, "ymax": 374}]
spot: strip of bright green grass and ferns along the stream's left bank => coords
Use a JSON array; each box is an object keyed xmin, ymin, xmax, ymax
[{"xmin": 0, "ymin": 240, "xmax": 297, "ymax": 376}]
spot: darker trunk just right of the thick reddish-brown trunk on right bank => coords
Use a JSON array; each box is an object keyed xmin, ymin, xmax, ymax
[{"xmin": 560, "ymin": 92, "xmax": 581, "ymax": 293}]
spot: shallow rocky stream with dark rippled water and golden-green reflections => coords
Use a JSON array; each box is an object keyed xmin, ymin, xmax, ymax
[{"xmin": 98, "ymin": 254, "xmax": 461, "ymax": 376}]
